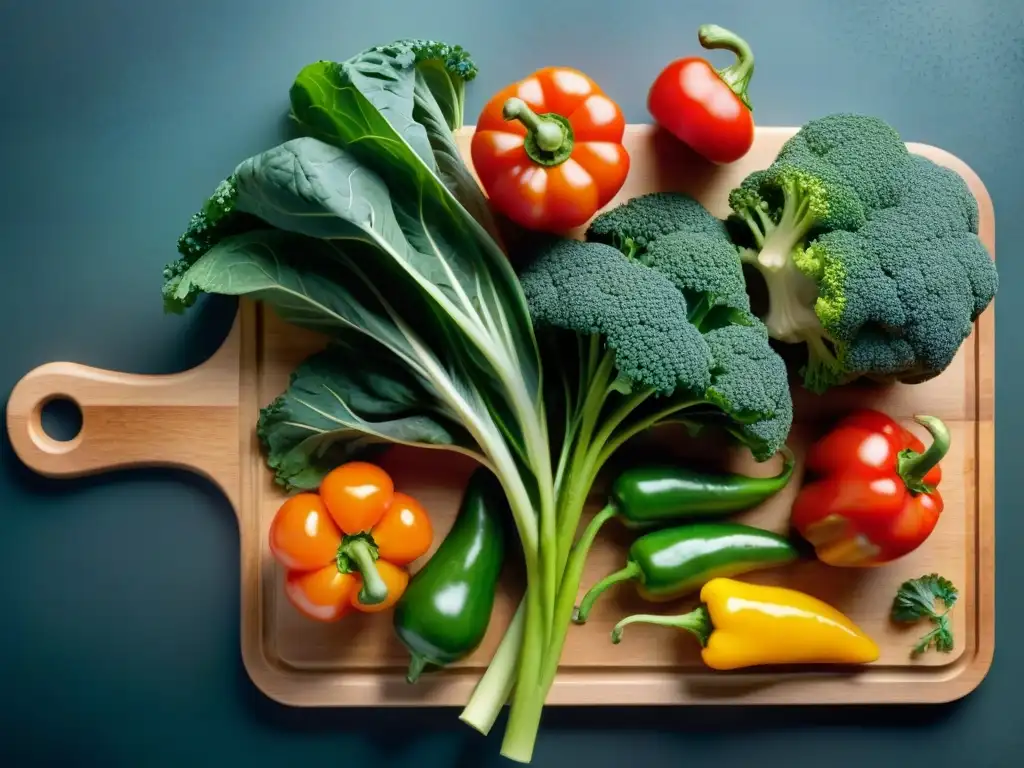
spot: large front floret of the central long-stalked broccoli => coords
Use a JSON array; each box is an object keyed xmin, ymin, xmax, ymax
[{"xmin": 520, "ymin": 239, "xmax": 712, "ymax": 395}]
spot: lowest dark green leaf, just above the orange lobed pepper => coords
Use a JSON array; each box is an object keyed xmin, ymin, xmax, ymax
[{"xmin": 258, "ymin": 336, "xmax": 483, "ymax": 489}]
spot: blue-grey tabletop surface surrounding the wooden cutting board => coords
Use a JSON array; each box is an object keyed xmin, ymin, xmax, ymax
[{"xmin": 0, "ymin": 0, "xmax": 1024, "ymax": 768}]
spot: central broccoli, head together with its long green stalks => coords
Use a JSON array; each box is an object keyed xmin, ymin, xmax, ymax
[{"xmin": 461, "ymin": 193, "xmax": 793, "ymax": 741}]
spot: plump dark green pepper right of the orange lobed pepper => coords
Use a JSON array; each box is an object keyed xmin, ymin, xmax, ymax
[{"xmin": 392, "ymin": 469, "xmax": 511, "ymax": 683}]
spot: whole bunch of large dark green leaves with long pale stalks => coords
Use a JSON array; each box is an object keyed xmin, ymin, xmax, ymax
[{"xmin": 164, "ymin": 41, "xmax": 560, "ymax": 757}]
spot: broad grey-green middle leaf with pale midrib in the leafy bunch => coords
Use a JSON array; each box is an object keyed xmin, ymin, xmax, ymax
[{"xmin": 225, "ymin": 137, "xmax": 538, "ymax": 468}]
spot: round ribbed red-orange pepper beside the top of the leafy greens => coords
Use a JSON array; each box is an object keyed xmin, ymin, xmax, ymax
[{"xmin": 470, "ymin": 67, "xmax": 630, "ymax": 232}]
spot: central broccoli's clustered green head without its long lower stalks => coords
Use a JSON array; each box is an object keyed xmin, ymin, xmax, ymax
[{"xmin": 520, "ymin": 193, "xmax": 793, "ymax": 461}]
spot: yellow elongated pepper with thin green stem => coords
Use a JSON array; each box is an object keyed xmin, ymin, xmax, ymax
[{"xmin": 611, "ymin": 579, "xmax": 879, "ymax": 670}]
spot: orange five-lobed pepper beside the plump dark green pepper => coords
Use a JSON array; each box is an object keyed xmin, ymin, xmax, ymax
[{"xmin": 270, "ymin": 462, "xmax": 433, "ymax": 622}]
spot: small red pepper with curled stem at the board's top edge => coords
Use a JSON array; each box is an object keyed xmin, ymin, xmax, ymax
[{"xmin": 647, "ymin": 25, "xmax": 754, "ymax": 164}]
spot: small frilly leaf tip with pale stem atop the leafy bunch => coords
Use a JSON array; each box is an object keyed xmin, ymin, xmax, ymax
[{"xmin": 370, "ymin": 39, "xmax": 478, "ymax": 131}]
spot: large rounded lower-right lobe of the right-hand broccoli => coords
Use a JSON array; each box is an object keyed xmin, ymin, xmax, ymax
[{"xmin": 808, "ymin": 187, "xmax": 997, "ymax": 381}]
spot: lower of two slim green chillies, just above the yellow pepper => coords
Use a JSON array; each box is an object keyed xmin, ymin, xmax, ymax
[{"xmin": 572, "ymin": 522, "xmax": 800, "ymax": 624}]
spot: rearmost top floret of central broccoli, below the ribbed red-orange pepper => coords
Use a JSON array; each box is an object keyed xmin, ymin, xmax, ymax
[{"xmin": 587, "ymin": 191, "xmax": 727, "ymax": 256}]
